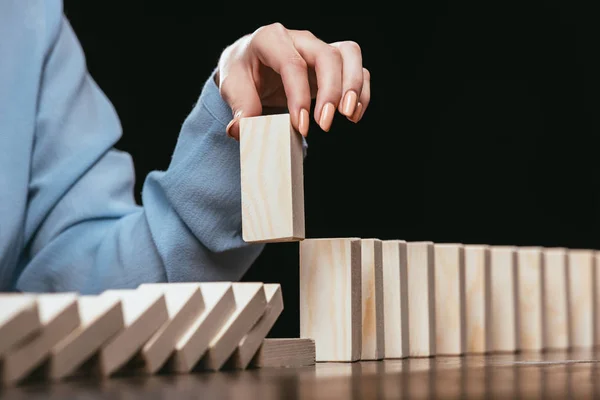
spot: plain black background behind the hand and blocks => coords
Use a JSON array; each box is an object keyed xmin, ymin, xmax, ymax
[{"xmin": 65, "ymin": 5, "xmax": 600, "ymax": 337}]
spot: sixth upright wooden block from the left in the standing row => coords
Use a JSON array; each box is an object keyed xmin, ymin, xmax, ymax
[{"xmin": 464, "ymin": 244, "xmax": 491, "ymax": 354}]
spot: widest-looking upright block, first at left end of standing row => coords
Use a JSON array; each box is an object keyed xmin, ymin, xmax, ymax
[{"xmin": 300, "ymin": 238, "xmax": 362, "ymax": 362}]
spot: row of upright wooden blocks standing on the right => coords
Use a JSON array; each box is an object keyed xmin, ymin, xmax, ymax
[{"xmin": 300, "ymin": 238, "xmax": 600, "ymax": 362}]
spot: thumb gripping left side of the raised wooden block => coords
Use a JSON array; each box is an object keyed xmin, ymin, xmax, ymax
[{"xmin": 220, "ymin": 70, "xmax": 262, "ymax": 140}]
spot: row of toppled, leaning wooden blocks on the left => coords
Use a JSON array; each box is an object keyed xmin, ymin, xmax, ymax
[{"xmin": 0, "ymin": 282, "xmax": 315, "ymax": 386}]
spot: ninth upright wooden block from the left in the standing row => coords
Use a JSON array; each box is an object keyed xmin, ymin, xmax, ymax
[{"xmin": 542, "ymin": 248, "xmax": 569, "ymax": 350}]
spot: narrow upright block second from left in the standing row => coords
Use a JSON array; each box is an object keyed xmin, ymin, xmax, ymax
[{"xmin": 360, "ymin": 239, "xmax": 385, "ymax": 360}]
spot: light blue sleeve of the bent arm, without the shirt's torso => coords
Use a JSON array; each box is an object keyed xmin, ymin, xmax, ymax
[{"xmin": 16, "ymin": 14, "xmax": 290, "ymax": 293}]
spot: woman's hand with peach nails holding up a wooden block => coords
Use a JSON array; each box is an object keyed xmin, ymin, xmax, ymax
[{"xmin": 215, "ymin": 23, "xmax": 371, "ymax": 140}]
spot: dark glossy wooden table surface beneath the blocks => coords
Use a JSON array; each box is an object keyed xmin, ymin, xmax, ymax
[{"xmin": 0, "ymin": 351, "xmax": 600, "ymax": 400}]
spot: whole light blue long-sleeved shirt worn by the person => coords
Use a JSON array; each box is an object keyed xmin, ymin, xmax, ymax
[{"xmin": 0, "ymin": 0, "xmax": 306, "ymax": 293}]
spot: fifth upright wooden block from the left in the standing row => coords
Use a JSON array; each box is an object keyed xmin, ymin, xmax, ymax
[{"xmin": 433, "ymin": 243, "xmax": 465, "ymax": 355}]
